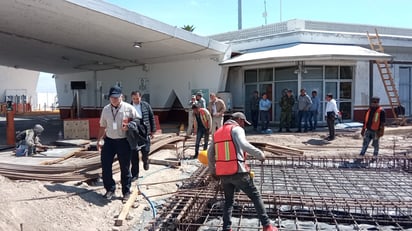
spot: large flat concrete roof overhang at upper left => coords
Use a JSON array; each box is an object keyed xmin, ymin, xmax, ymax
[{"xmin": 0, "ymin": 0, "xmax": 229, "ymax": 73}]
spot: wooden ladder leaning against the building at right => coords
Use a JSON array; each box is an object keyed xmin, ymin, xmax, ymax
[{"xmin": 366, "ymin": 29, "xmax": 406, "ymax": 125}]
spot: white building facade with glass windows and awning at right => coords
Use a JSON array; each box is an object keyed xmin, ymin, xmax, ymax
[{"xmin": 212, "ymin": 20, "xmax": 412, "ymax": 122}]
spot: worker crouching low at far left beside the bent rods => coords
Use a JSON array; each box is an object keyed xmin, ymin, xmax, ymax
[{"xmin": 16, "ymin": 124, "xmax": 48, "ymax": 156}]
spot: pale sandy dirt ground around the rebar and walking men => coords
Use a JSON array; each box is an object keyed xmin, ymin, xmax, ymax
[{"xmin": 0, "ymin": 126, "xmax": 412, "ymax": 231}]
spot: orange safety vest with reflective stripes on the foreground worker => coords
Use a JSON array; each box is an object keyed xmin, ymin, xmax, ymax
[{"xmin": 213, "ymin": 124, "xmax": 248, "ymax": 176}]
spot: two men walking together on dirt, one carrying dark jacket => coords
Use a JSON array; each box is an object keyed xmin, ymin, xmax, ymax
[{"xmin": 97, "ymin": 86, "xmax": 156, "ymax": 201}]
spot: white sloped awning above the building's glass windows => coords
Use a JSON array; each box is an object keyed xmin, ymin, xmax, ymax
[{"xmin": 221, "ymin": 44, "xmax": 392, "ymax": 66}]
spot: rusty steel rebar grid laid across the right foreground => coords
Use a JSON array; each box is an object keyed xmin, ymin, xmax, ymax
[{"xmin": 150, "ymin": 156, "xmax": 412, "ymax": 231}]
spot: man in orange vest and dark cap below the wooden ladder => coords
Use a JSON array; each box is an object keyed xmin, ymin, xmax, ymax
[{"xmin": 360, "ymin": 97, "xmax": 386, "ymax": 157}]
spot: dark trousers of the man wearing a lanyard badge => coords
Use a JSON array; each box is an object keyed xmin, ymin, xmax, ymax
[{"xmin": 100, "ymin": 137, "xmax": 132, "ymax": 195}]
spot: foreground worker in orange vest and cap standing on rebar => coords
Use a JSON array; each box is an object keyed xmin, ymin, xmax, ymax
[{"xmin": 208, "ymin": 112, "xmax": 277, "ymax": 231}]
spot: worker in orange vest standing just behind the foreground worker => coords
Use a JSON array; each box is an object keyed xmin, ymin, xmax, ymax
[{"xmin": 192, "ymin": 104, "xmax": 212, "ymax": 159}]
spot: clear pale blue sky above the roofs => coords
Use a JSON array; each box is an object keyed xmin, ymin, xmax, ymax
[{"xmin": 105, "ymin": 0, "xmax": 412, "ymax": 35}]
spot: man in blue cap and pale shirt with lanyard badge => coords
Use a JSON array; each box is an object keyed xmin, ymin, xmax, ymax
[{"xmin": 97, "ymin": 86, "xmax": 138, "ymax": 201}]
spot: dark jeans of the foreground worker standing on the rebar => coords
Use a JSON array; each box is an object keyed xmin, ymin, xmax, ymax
[{"xmin": 221, "ymin": 173, "xmax": 270, "ymax": 230}]
